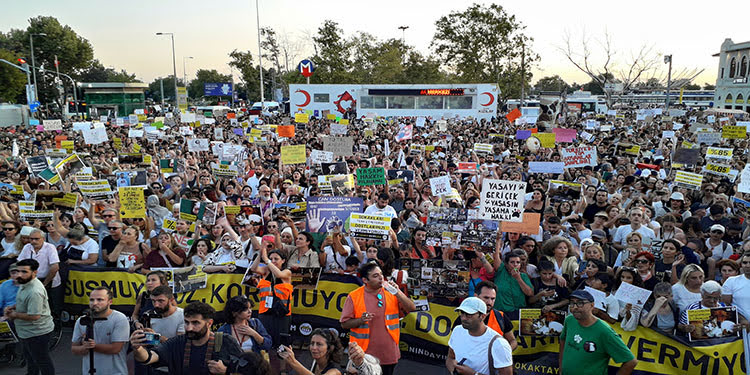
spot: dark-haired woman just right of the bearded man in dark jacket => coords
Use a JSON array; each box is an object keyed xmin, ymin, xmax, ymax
[{"xmin": 217, "ymin": 296, "xmax": 272, "ymax": 353}]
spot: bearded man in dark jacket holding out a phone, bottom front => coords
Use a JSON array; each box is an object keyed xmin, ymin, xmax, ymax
[{"xmin": 130, "ymin": 302, "xmax": 242, "ymax": 375}]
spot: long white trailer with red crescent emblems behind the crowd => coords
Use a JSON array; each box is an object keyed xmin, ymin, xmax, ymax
[{"xmin": 289, "ymin": 83, "xmax": 500, "ymax": 120}]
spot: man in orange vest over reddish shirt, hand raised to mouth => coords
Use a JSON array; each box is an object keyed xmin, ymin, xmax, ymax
[{"xmin": 339, "ymin": 262, "xmax": 416, "ymax": 375}]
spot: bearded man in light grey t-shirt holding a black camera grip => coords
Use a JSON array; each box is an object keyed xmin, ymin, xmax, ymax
[{"xmin": 71, "ymin": 286, "xmax": 130, "ymax": 375}]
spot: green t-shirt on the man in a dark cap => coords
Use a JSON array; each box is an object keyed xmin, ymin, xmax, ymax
[{"xmin": 560, "ymin": 315, "xmax": 635, "ymax": 375}]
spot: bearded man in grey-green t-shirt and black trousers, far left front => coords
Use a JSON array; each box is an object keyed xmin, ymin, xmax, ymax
[{"xmin": 5, "ymin": 259, "xmax": 55, "ymax": 375}]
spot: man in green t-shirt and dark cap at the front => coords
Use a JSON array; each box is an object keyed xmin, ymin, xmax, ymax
[{"xmin": 558, "ymin": 290, "xmax": 638, "ymax": 375}]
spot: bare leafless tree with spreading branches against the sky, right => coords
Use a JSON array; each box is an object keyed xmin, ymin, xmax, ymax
[{"xmin": 558, "ymin": 32, "xmax": 660, "ymax": 107}]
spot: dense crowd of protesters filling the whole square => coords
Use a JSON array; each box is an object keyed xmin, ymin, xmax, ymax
[{"xmin": 0, "ymin": 100, "xmax": 750, "ymax": 375}]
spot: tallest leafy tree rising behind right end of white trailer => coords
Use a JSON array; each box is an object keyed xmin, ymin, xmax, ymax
[{"xmin": 431, "ymin": 4, "xmax": 539, "ymax": 104}]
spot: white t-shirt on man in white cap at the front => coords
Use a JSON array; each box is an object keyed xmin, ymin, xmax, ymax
[{"xmin": 448, "ymin": 325, "xmax": 513, "ymax": 374}]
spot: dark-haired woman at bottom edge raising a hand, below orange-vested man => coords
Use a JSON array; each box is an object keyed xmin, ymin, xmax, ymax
[{"xmin": 279, "ymin": 328, "xmax": 343, "ymax": 375}]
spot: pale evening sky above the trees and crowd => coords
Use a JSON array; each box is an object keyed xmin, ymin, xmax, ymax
[{"xmin": 0, "ymin": 0, "xmax": 750, "ymax": 86}]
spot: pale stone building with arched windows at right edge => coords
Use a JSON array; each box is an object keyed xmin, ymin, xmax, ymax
[{"xmin": 713, "ymin": 38, "xmax": 750, "ymax": 112}]
